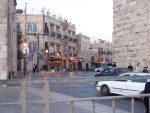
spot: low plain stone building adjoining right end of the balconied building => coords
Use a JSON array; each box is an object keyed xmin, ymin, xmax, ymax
[{"xmin": 76, "ymin": 33, "xmax": 99, "ymax": 70}]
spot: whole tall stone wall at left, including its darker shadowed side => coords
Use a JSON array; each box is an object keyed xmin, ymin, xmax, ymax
[{"xmin": 0, "ymin": 0, "xmax": 17, "ymax": 79}]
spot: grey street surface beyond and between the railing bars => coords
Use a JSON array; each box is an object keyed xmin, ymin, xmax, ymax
[{"xmin": 0, "ymin": 72, "xmax": 145, "ymax": 113}]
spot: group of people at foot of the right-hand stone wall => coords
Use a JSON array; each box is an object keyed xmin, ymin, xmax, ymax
[{"xmin": 128, "ymin": 63, "xmax": 149, "ymax": 73}]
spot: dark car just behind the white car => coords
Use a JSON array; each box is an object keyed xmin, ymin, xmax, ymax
[{"xmin": 95, "ymin": 67, "xmax": 131, "ymax": 77}]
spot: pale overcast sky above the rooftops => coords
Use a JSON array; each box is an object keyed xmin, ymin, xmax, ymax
[{"xmin": 17, "ymin": 0, "xmax": 113, "ymax": 42}]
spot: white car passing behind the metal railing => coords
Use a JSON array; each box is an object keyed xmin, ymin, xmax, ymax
[{"xmin": 96, "ymin": 72, "xmax": 150, "ymax": 96}]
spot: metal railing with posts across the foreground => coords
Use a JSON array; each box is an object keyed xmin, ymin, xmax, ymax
[{"xmin": 0, "ymin": 76, "xmax": 150, "ymax": 113}]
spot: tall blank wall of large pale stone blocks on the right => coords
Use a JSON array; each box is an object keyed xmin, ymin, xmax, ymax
[{"xmin": 113, "ymin": 0, "xmax": 150, "ymax": 67}]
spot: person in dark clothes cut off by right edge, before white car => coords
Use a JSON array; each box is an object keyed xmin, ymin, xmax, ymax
[{"xmin": 144, "ymin": 81, "xmax": 150, "ymax": 113}]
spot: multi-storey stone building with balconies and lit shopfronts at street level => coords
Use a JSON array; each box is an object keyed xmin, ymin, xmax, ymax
[{"xmin": 17, "ymin": 11, "xmax": 77, "ymax": 71}]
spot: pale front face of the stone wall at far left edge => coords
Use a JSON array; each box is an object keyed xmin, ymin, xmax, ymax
[{"xmin": 0, "ymin": 0, "xmax": 8, "ymax": 79}]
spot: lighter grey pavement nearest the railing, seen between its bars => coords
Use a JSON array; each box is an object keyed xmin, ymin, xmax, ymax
[{"xmin": 0, "ymin": 71, "xmax": 129, "ymax": 113}]
